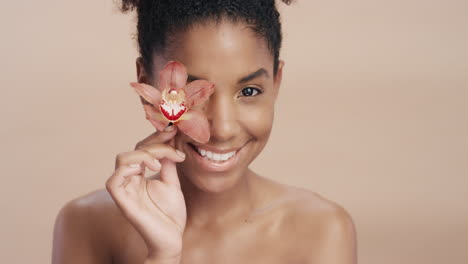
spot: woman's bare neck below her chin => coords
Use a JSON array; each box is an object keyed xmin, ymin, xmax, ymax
[{"xmin": 179, "ymin": 170, "xmax": 255, "ymax": 226}]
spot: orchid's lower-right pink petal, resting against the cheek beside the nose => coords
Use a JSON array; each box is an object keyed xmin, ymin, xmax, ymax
[{"xmin": 177, "ymin": 110, "xmax": 210, "ymax": 143}]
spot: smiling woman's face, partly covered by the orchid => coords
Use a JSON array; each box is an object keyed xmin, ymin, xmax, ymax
[{"xmin": 144, "ymin": 18, "xmax": 283, "ymax": 192}]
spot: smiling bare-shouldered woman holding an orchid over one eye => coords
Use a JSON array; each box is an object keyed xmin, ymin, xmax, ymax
[{"xmin": 52, "ymin": 0, "xmax": 357, "ymax": 264}]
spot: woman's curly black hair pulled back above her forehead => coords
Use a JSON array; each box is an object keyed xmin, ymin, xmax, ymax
[{"xmin": 120, "ymin": 0, "xmax": 292, "ymax": 78}]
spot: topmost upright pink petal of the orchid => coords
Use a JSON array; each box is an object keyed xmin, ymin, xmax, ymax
[{"xmin": 159, "ymin": 61, "xmax": 187, "ymax": 91}]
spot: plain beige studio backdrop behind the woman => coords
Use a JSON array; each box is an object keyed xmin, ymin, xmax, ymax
[{"xmin": 0, "ymin": 0, "xmax": 468, "ymax": 264}]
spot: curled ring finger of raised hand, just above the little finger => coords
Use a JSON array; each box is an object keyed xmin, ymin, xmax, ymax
[{"xmin": 115, "ymin": 150, "xmax": 161, "ymax": 171}]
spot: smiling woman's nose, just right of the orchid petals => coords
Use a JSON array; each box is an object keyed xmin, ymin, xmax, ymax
[{"xmin": 207, "ymin": 90, "xmax": 240, "ymax": 142}]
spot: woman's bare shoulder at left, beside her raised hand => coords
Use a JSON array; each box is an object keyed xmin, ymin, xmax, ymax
[{"xmin": 53, "ymin": 189, "xmax": 125, "ymax": 263}]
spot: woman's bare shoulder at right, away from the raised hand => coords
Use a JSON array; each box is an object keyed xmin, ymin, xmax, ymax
[{"xmin": 256, "ymin": 177, "xmax": 357, "ymax": 264}]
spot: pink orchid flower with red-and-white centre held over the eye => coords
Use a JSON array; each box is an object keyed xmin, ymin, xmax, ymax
[{"xmin": 130, "ymin": 61, "xmax": 214, "ymax": 143}]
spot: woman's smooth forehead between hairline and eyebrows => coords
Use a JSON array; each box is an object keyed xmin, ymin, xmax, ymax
[{"xmin": 165, "ymin": 20, "xmax": 273, "ymax": 81}]
